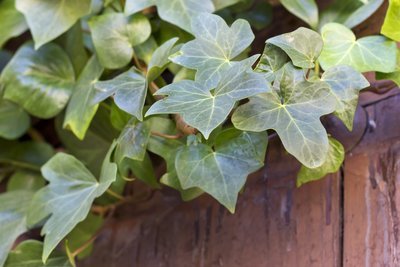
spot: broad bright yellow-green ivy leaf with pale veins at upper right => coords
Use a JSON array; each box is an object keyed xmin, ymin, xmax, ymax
[{"xmin": 319, "ymin": 23, "xmax": 397, "ymax": 72}]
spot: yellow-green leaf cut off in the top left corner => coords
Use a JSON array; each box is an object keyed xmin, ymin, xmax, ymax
[{"xmin": 0, "ymin": 0, "xmax": 28, "ymax": 47}]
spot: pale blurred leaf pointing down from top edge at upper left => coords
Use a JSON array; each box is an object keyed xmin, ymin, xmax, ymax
[{"xmin": 15, "ymin": 0, "xmax": 91, "ymax": 49}]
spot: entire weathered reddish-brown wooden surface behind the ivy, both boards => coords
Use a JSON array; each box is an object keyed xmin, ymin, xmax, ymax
[{"xmin": 78, "ymin": 3, "xmax": 400, "ymax": 267}]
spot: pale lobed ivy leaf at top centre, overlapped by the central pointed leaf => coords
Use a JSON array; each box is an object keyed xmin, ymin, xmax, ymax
[{"xmin": 171, "ymin": 13, "xmax": 254, "ymax": 87}]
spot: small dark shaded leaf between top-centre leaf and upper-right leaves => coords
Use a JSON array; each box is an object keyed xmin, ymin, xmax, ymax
[{"xmin": 255, "ymin": 43, "xmax": 289, "ymax": 82}]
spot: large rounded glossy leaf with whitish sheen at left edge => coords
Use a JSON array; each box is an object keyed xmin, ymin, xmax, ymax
[{"xmin": 0, "ymin": 44, "xmax": 75, "ymax": 119}]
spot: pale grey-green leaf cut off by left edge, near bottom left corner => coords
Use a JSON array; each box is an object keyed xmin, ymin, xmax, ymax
[{"xmin": 0, "ymin": 190, "xmax": 33, "ymax": 266}]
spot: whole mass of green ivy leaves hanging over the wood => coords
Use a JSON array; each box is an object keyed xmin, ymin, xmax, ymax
[{"xmin": 0, "ymin": 0, "xmax": 400, "ymax": 267}]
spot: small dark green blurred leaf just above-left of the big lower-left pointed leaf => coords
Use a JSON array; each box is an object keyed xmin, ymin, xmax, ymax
[{"xmin": 7, "ymin": 171, "xmax": 45, "ymax": 192}]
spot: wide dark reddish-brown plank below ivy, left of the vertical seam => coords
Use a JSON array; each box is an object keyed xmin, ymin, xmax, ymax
[{"xmin": 79, "ymin": 143, "xmax": 340, "ymax": 267}]
